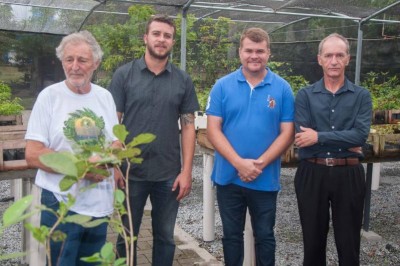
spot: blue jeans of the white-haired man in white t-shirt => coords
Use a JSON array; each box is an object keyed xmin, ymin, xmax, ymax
[{"xmin": 40, "ymin": 189, "xmax": 107, "ymax": 266}]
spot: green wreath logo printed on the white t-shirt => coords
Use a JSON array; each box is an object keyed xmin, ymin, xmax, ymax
[{"xmin": 63, "ymin": 108, "xmax": 105, "ymax": 146}]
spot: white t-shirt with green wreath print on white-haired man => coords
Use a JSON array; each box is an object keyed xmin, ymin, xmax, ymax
[{"xmin": 25, "ymin": 81, "xmax": 118, "ymax": 217}]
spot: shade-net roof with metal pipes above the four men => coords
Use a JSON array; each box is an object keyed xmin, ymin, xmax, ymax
[{"xmin": 0, "ymin": 0, "xmax": 400, "ymax": 35}]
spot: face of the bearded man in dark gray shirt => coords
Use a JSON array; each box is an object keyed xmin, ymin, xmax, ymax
[{"xmin": 144, "ymin": 21, "xmax": 175, "ymax": 60}]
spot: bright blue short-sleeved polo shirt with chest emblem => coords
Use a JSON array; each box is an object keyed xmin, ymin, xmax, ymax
[{"xmin": 206, "ymin": 68, "xmax": 294, "ymax": 191}]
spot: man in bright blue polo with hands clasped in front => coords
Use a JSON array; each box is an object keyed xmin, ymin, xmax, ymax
[{"xmin": 206, "ymin": 28, "xmax": 294, "ymax": 266}]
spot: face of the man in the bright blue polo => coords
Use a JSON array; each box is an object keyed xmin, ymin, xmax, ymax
[{"xmin": 239, "ymin": 38, "xmax": 270, "ymax": 74}]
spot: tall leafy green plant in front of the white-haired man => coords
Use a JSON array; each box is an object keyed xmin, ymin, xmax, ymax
[{"xmin": 0, "ymin": 125, "xmax": 156, "ymax": 266}]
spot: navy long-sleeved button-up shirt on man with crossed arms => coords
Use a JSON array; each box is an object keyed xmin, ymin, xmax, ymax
[{"xmin": 295, "ymin": 79, "xmax": 372, "ymax": 159}]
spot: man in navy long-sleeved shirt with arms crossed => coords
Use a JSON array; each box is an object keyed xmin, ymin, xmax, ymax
[{"xmin": 295, "ymin": 33, "xmax": 372, "ymax": 266}]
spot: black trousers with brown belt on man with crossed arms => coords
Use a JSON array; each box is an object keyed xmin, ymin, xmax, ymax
[{"xmin": 294, "ymin": 161, "xmax": 365, "ymax": 266}]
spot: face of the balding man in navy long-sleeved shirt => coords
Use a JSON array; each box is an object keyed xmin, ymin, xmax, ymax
[{"xmin": 318, "ymin": 37, "xmax": 350, "ymax": 78}]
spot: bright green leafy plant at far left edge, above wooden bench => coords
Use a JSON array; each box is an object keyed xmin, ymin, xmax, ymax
[{"xmin": 0, "ymin": 81, "xmax": 24, "ymax": 115}]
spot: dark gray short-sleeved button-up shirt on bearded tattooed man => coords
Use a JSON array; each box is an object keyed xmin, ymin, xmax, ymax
[{"xmin": 109, "ymin": 57, "xmax": 199, "ymax": 181}]
